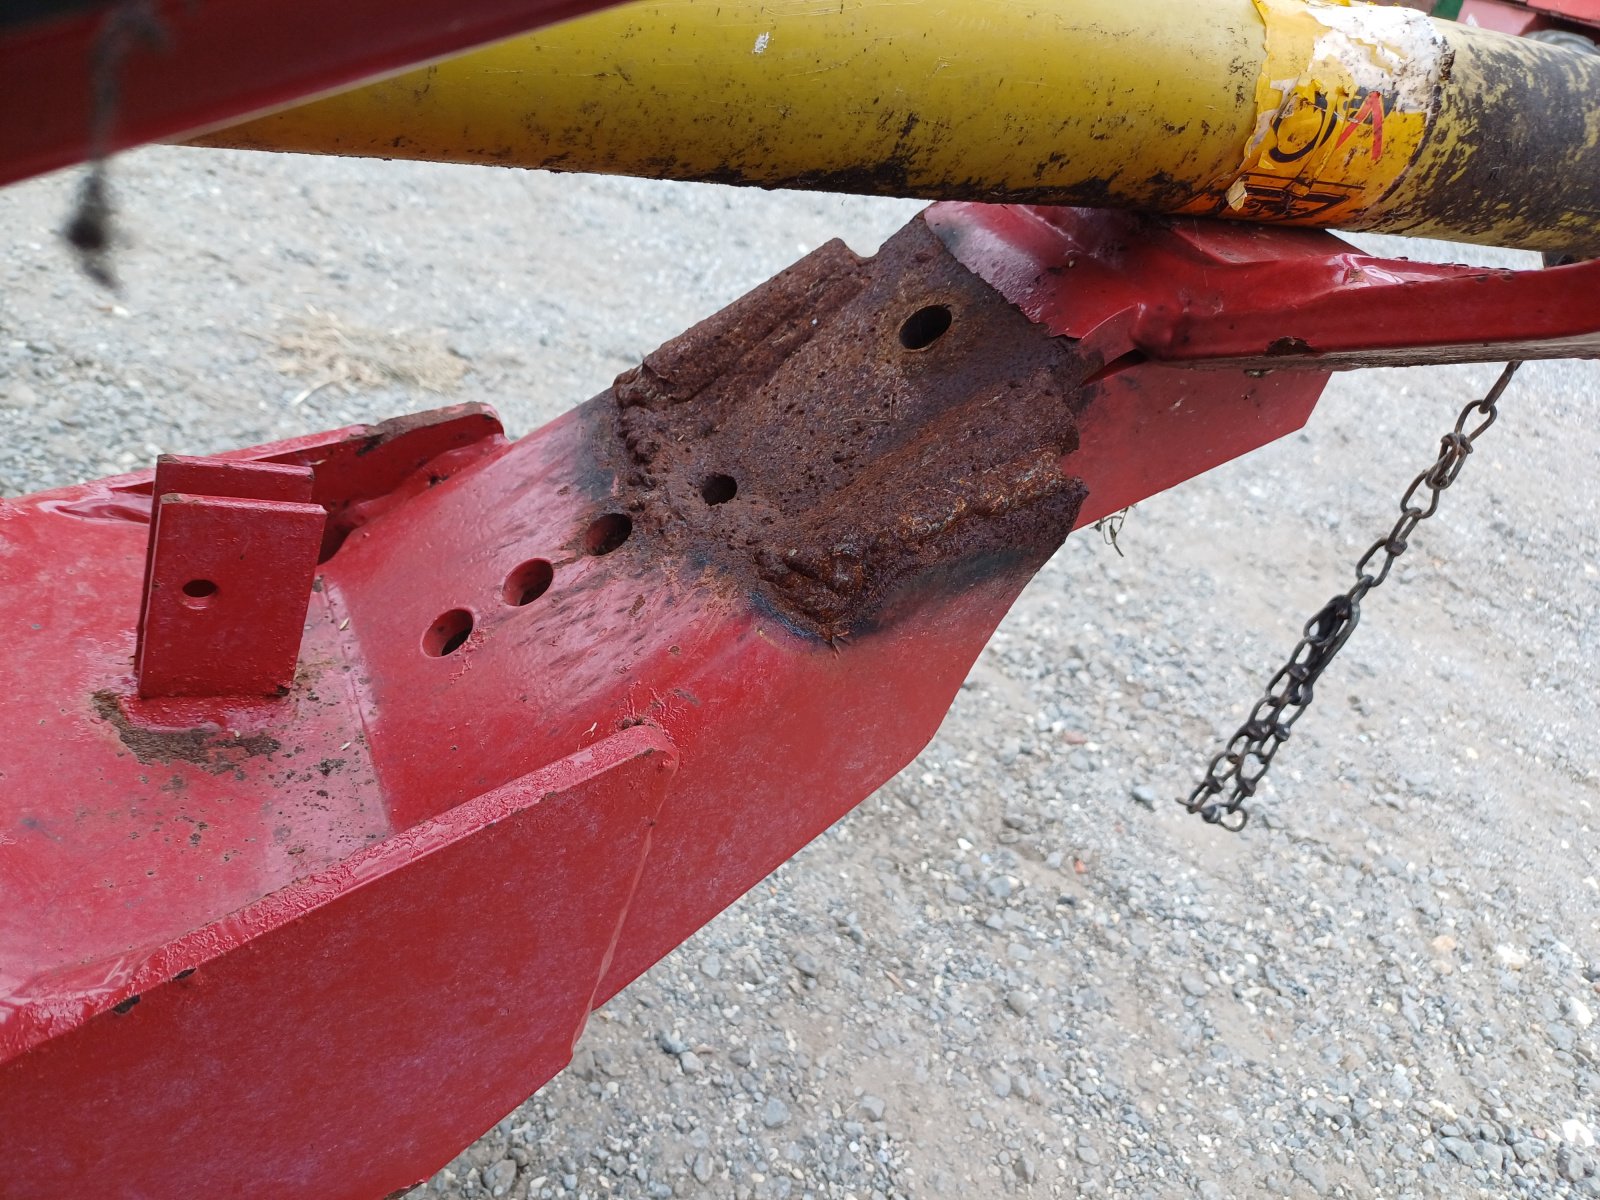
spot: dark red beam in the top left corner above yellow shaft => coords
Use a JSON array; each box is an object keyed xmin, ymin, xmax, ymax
[{"xmin": 0, "ymin": 0, "xmax": 617, "ymax": 186}]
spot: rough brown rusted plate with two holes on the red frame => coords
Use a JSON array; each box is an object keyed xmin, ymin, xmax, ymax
[{"xmin": 610, "ymin": 221, "xmax": 1093, "ymax": 638}]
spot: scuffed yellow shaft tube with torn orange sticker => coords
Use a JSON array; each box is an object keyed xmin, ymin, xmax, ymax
[{"xmin": 197, "ymin": 0, "xmax": 1600, "ymax": 254}]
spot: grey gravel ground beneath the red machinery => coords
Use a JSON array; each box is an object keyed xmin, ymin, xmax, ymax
[{"xmin": 0, "ymin": 149, "xmax": 1600, "ymax": 1200}]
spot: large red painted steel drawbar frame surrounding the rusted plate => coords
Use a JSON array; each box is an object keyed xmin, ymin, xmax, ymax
[{"xmin": 0, "ymin": 205, "xmax": 1593, "ymax": 1200}]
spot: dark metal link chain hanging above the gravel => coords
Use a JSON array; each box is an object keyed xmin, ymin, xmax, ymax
[{"xmin": 1178, "ymin": 362, "xmax": 1522, "ymax": 834}]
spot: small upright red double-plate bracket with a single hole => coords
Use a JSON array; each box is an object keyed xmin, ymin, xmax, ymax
[{"xmin": 136, "ymin": 454, "xmax": 326, "ymax": 699}]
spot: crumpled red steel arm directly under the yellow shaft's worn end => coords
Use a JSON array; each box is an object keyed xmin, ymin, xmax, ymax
[{"xmin": 930, "ymin": 203, "xmax": 1600, "ymax": 370}]
